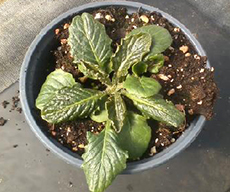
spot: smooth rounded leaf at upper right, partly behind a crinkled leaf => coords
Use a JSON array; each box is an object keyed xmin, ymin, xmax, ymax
[{"xmin": 127, "ymin": 25, "xmax": 172, "ymax": 55}]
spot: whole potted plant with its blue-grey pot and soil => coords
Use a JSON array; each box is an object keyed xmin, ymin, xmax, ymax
[{"xmin": 20, "ymin": 2, "xmax": 217, "ymax": 192}]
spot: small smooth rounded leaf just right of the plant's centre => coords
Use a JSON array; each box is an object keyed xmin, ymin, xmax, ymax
[{"xmin": 123, "ymin": 75, "xmax": 161, "ymax": 97}]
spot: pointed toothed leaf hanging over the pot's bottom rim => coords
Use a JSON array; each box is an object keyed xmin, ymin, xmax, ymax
[{"xmin": 82, "ymin": 121, "xmax": 128, "ymax": 192}]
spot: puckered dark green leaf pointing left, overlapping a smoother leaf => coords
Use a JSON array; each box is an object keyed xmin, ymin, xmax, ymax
[{"xmin": 41, "ymin": 85, "xmax": 105, "ymax": 123}]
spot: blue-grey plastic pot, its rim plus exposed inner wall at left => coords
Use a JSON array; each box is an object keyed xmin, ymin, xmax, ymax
[{"xmin": 20, "ymin": 1, "xmax": 207, "ymax": 174}]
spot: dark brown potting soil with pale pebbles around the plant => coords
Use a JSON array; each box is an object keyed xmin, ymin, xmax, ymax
[{"xmin": 44, "ymin": 7, "xmax": 218, "ymax": 157}]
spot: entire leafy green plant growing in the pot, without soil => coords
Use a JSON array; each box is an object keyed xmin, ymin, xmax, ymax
[{"xmin": 36, "ymin": 13, "xmax": 185, "ymax": 192}]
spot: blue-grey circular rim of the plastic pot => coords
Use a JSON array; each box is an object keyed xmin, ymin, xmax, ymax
[{"xmin": 19, "ymin": 1, "xmax": 207, "ymax": 174}]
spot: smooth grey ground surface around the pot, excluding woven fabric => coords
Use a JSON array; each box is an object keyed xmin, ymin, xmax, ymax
[{"xmin": 0, "ymin": 0, "xmax": 230, "ymax": 192}]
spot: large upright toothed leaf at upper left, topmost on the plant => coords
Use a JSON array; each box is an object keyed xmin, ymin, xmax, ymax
[{"xmin": 68, "ymin": 13, "xmax": 112, "ymax": 73}]
